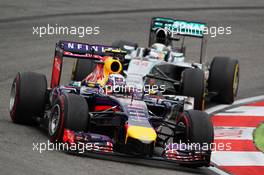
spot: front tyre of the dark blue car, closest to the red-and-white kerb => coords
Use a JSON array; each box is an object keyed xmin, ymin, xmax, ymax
[{"xmin": 176, "ymin": 110, "xmax": 214, "ymax": 167}]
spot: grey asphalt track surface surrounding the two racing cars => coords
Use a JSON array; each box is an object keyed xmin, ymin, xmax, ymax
[{"xmin": 0, "ymin": 0, "xmax": 264, "ymax": 175}]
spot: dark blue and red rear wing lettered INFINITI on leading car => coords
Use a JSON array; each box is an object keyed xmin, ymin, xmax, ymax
[{"xmin": 50, "ymin": 41, "xmax": 120, "ymax": 88}]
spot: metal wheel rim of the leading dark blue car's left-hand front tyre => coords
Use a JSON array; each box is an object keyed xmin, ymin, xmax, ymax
[{"xmin": 49, "ymin": 104, "xmax": 61, "ymax": 135}]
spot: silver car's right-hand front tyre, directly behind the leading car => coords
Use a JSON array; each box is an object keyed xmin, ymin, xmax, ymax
[{"xmin": 181, "ymin": 68, "xmax": 205, "ymax": 110}]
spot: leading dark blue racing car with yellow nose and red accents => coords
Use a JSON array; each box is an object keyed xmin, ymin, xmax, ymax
[{"xmin": 10, "ymin": 41, "xmax": 214, "ymax": 166}]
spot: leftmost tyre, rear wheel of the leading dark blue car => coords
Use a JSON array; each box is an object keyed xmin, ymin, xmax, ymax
[{"xmin": 9, "ymin": 72, "xmax": 47, "ymax": 125}]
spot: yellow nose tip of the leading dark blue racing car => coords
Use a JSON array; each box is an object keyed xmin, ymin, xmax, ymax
[{"xmin": 126, "ymin": 126, "xmax": 157, "ymax": 144}]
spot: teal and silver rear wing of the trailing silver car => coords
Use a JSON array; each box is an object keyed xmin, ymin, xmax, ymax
[{"xmin": 149, "ymin": 17, "xmax": 207, "ymax": 63}]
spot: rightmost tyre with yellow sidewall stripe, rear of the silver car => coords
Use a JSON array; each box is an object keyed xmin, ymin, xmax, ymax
[{"xmin": 208, "ymin": 57, "xmax": 239, "ymax": 104}]
